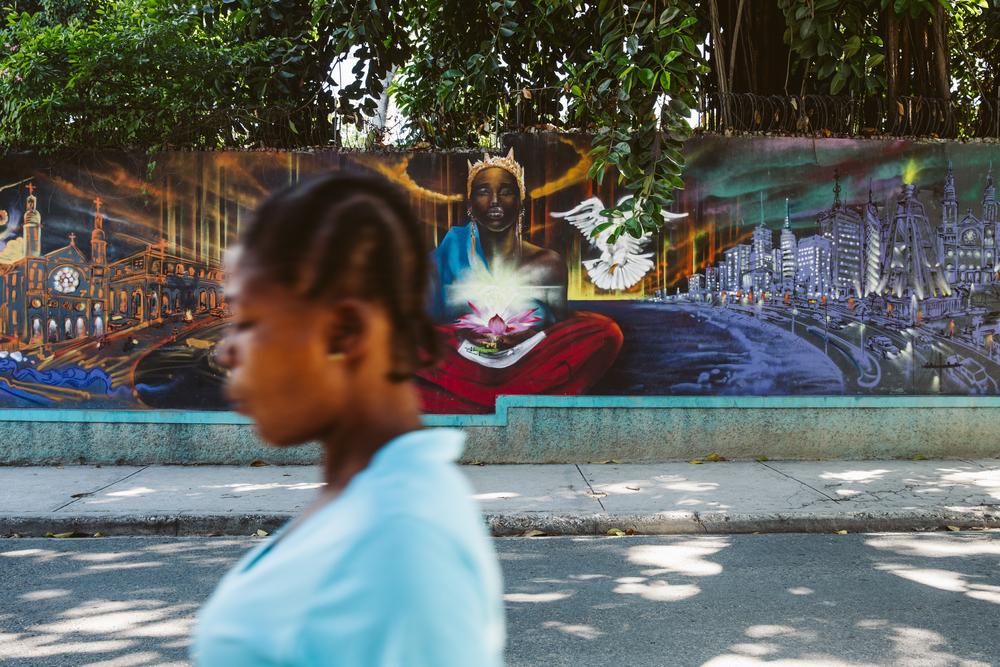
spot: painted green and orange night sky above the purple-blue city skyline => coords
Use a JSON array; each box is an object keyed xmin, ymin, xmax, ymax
[{"xmin": 666, "ymin": 137, "xmax": 1000, "ymax": 287}]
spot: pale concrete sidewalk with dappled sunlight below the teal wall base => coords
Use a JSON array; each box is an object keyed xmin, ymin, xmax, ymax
[{"xmin": 0, "ymin": 459, "xmax": 1000, "ymax": 536}]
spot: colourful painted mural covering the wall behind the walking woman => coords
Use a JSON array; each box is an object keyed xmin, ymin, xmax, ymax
[{"xmin": 0, "ymin": 134, "xmax": 1000, "ymax": 413}]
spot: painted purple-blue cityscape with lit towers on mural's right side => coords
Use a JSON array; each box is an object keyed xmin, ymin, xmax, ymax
[{"xmin": 653, "ymin": 141, "xmax": 1000, "ymax": 395}]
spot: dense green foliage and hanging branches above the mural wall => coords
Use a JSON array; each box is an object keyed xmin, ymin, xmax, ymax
[{"xmin": 0, "ymin": 0, "xmax": 1000, "ymax": 239}]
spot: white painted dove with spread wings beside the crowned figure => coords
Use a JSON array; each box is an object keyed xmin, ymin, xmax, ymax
[{"xmin": 551, "ymin": 195, "xmax": 687, "ymax": 290}]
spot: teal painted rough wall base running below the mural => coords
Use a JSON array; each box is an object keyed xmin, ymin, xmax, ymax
[{"xmin": 0, "ymin": 396, "xmax": 1000, "ymax": 465}]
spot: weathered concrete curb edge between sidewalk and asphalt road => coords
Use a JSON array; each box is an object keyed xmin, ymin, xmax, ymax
[{"xmin": 0, "ymin": 506, "xmax": 1000, "ymax": 537}]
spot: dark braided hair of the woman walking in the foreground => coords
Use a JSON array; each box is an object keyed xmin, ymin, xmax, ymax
[{"xmin": 240, "ymin": 173, "xmax": 437, "ymax": 382}]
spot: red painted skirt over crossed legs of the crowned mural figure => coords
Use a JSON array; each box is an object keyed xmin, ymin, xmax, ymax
[{"xmin": 417, "ymin": 311, "xmax": 622, "ymax": 414}]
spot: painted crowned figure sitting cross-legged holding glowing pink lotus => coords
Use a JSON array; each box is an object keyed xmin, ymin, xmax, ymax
[{"xmin": 419, "ymin": 150, "xmax": 622, "ymax": 413}]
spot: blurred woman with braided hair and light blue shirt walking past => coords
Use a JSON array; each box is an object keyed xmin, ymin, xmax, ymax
[{"xmin": 192, "ymin": 175, "xmax": 504, "ymax": 667}]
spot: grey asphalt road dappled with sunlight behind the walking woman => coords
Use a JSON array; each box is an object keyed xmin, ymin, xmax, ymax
[{"xmin": 0, "ymin": 532, "xmax": 1000, "ymax": 667}]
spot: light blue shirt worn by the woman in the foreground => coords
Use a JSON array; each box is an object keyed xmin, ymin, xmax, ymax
[{"xmin": 192, "ymin": 429, "xmax": 505, "ymax": 667}]
